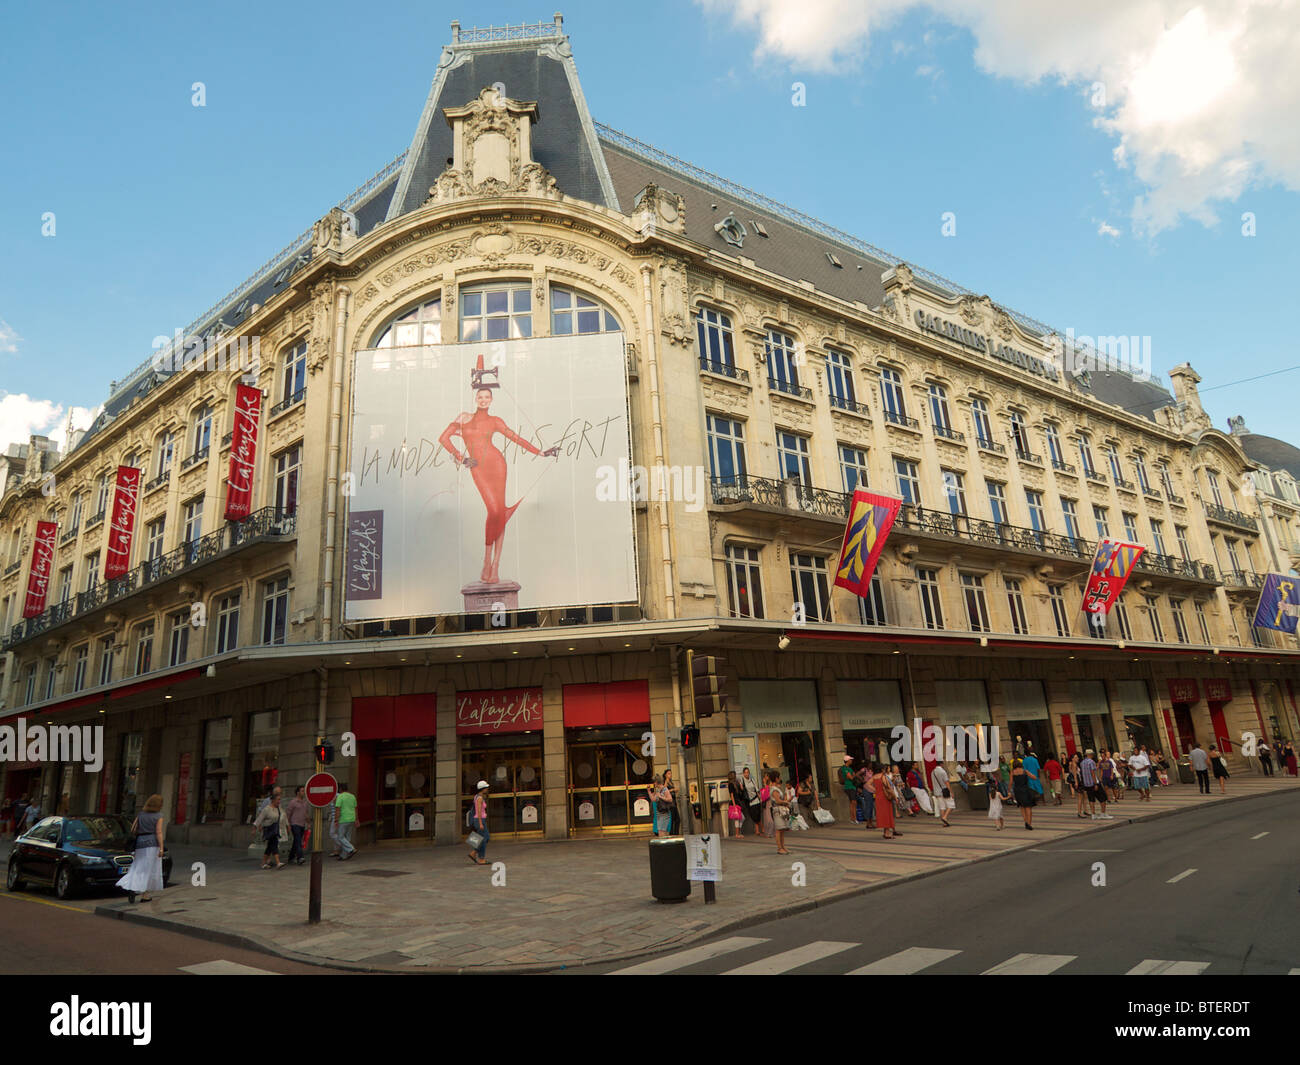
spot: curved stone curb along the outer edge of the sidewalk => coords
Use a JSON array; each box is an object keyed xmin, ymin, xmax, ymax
[{"xmin": 92, "ymin": 792, "xmax": 1295, "ymax": 977}]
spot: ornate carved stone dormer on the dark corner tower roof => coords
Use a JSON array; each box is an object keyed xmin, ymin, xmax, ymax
[{"xmin": 425, "ymin": 86, "xmax": 560, "ymax": 203}]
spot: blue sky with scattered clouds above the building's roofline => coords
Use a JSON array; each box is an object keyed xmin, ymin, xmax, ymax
[{"xmin": 0, "ymin": 0, "xmax": 1300, "ymax": 447}]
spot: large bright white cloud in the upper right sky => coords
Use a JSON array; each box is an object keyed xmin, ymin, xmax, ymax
[{"xmin": 697, "ymin": 0, "xmax": 1300, "ymax": 233}]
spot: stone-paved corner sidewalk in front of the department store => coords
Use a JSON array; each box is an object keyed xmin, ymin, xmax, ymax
[{"xmin": 95, "ymin": 776, "xmax": 1300, "ymax": 973}]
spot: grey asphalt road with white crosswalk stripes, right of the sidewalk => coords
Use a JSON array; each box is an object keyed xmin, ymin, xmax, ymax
[{"xmin": 579, "ymin": 795, "xmax": 1300, "ymax": 975}]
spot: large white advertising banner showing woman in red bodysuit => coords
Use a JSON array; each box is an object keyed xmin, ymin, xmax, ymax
[{"xmin": 345, "ymin": 333, "xmax": 637, "ymax": 620}]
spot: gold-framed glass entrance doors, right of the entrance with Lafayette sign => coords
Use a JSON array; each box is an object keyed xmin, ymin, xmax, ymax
[{"xmin": 568, "ymin": 733, "xmax": 655, "ymax": 835}]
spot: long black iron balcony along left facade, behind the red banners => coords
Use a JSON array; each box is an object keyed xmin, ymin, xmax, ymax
[{"xmin": 0, "ymin": 507, "xmax": 298, "ymax": 651}]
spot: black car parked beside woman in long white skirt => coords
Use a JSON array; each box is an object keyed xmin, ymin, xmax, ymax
[{"xmin": 5, "ymin": 814, "xmax": 172, "ymax": 899}]
